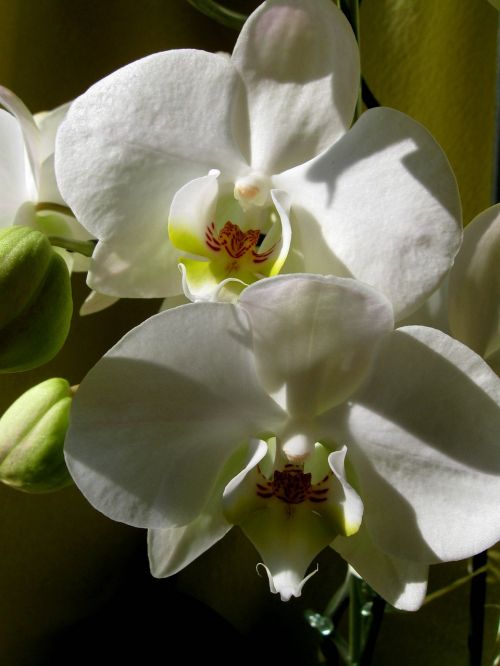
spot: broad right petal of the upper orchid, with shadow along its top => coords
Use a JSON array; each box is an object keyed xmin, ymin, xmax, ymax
[{"xmin": 274, "ymin": 109, "xmax": 461, "ymax": 320}]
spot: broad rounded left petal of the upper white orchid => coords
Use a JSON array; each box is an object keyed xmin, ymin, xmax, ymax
[{"xmin": 56, "ymin": 50, "xmax": 244, "ymax": 255}]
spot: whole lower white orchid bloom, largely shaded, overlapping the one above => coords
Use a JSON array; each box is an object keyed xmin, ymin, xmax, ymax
[{"xmin": 66, "ymin": 275, "xmax": 500, "ymax": 609}]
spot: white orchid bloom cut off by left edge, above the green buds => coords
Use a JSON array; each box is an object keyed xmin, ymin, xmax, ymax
[{"xmin": 0, "ymin": 86, "xmax": 91, "ymax": 270}]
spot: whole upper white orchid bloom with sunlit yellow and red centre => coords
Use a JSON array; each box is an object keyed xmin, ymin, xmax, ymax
[{"xmin": 56, "ymin": 0, "xmax": 461, "ymax": 319}]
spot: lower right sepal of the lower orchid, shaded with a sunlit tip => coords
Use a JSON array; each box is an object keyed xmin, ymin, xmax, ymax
[{"xmin": 331, "ymin": 525, "xmax": 428, "ymax": 611}]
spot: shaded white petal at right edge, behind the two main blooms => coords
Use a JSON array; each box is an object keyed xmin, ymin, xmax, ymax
[{"xmin": 449, "ymin": 204, "xmax": 500, "ymax": 356}]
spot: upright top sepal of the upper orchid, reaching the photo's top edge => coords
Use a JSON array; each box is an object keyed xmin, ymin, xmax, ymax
[{"xmin": 232, "ymin": 0, "xmax": 359, "ymax": 174}]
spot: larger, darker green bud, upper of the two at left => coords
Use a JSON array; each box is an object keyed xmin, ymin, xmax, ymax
[{"xmin": 0, "ymin": 227, "xmax": 73, "ymax": 372}]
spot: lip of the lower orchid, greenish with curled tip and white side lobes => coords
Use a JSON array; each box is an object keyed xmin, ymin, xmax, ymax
[{"xmin": 224, "ymin": 442, "xmax": 362, "ymax": 601}]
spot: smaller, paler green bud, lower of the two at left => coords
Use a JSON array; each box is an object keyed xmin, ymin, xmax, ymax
[{"xmin": 0, "ymin": 378, "xmax": 72, "ymax": 493}]
